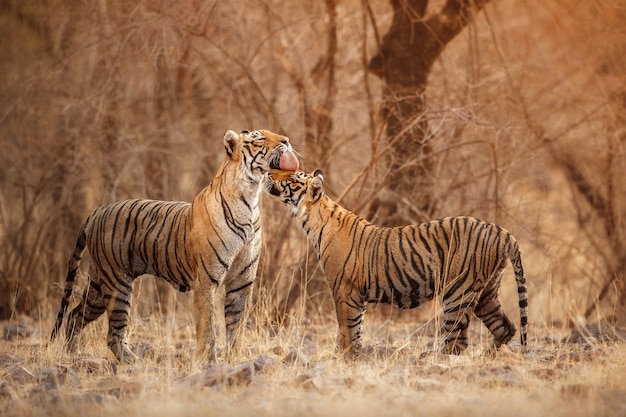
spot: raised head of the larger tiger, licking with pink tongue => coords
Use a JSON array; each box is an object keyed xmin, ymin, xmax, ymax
[{"xmin": 224, "ymin": 130, "xmax": 300, "ymax": 181}]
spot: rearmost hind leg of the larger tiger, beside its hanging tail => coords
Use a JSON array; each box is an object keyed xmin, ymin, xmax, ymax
[{"xmin": 65, "ymin": 279, "xmax": 105, "ymax": 352}]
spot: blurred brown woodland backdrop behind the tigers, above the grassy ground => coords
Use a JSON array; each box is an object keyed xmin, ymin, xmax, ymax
[{"xmin": 0, "ymin": 0, "xmax": 626, "ymax": 326}]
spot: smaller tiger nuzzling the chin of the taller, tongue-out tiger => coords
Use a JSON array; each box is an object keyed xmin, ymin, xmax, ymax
[{"xmin": 267, "ymin": 170, "xmax": 528, "ymax": 355}]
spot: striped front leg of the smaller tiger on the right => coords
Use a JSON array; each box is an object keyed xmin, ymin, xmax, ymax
[{"xmin": 335, "ymin": 297, "xmax": 366, "ymax": 359}]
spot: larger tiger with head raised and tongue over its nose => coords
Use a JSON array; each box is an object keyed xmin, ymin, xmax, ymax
[{"xmin": 51, "ymin": 130, "xmax": 298, "ymax": 363}]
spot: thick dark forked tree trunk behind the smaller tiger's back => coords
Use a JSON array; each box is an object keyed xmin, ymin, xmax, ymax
[{"xmin": 368, "ymin": 0, "xmax": 488, "ymax": 225}]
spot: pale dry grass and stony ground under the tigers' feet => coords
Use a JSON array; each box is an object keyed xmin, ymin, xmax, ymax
[{"xmin": 0, "ymin": 309, "xmax": 626, "ymax": 417}]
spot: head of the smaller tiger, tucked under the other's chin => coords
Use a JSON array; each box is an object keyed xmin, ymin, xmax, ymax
[{"xmin": 266, "ymin": 169, "xmax": 324, "ymax": 217}]
